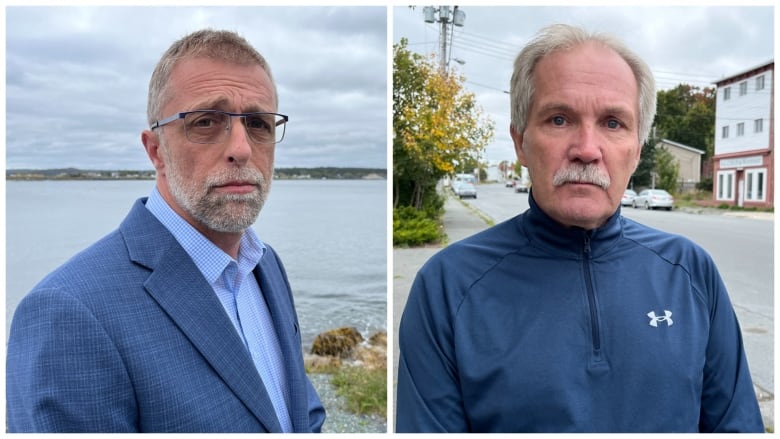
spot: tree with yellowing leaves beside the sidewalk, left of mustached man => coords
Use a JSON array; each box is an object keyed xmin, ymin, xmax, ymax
[{"xmin": 393, "ymin": 38, "xmax": 494, "ymax": 209}]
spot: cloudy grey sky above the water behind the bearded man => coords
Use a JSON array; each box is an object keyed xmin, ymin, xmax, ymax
[{"xmin": 6, "ymin": 6, "xmax": 388, "ymax": 169}]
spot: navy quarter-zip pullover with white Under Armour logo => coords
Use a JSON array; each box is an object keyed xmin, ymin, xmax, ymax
[{"xmin": 396, "ymin": 196, "xmax": 764, "ymax": 432}]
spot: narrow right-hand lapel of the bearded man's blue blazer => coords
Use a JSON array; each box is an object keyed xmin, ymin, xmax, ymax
[{"xmin": 255, "ymin": 247, "xmax": 310, "ymax": 432}]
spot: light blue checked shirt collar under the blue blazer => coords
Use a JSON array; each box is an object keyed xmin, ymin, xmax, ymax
[{"xmin": 146, "ymin": 186, "xmax": 266, "ymax": 284}]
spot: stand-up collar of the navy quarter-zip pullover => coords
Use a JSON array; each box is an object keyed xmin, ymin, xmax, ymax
[{"xmin": 521, "ymin": 190, "xmax": 623, "ymax": 259}]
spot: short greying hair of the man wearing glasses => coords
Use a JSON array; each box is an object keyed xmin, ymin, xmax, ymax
[{"xmin": 146, "ymin": 29, "xmax": 278, "ymax": 126}]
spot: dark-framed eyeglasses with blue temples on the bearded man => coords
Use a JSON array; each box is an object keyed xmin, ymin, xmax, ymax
[{"xmin": 152, "ymin": 110, "xmax": 290, "ymax": 143}]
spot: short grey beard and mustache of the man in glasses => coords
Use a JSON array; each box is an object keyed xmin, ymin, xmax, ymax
[{"xmin": 163, "ymin": 142, "xmax": 271, "ymax": 233}]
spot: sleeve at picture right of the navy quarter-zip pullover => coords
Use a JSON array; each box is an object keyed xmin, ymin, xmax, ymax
[{"xmin": 699, "ymin": 266, "xmax": 764, "ymax": 433}]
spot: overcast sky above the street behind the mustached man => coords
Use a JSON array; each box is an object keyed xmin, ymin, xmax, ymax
[{"xmin": 393, "ymin": 6, "xmax": 774, "ymax": 165}]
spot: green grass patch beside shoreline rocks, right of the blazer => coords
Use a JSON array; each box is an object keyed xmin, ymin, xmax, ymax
[{"xmin": 331, "ymin": 366, "xmax": 387, "ymax": 417}]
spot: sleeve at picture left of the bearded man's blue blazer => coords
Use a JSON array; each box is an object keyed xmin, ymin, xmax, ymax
[{"xmin": 6, "ymin": 289, "xmax": 137, "ymax": 432}]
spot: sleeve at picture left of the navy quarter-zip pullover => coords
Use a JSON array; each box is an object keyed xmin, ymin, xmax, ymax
[{"xmin": 396, "ymin": 264, "xmax": 468, "ymax": 433}]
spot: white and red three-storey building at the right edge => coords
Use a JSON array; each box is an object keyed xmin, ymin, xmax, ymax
[{"xmin": 713, "ymin": 60, "xmax": 775, "ymax": 207}]
